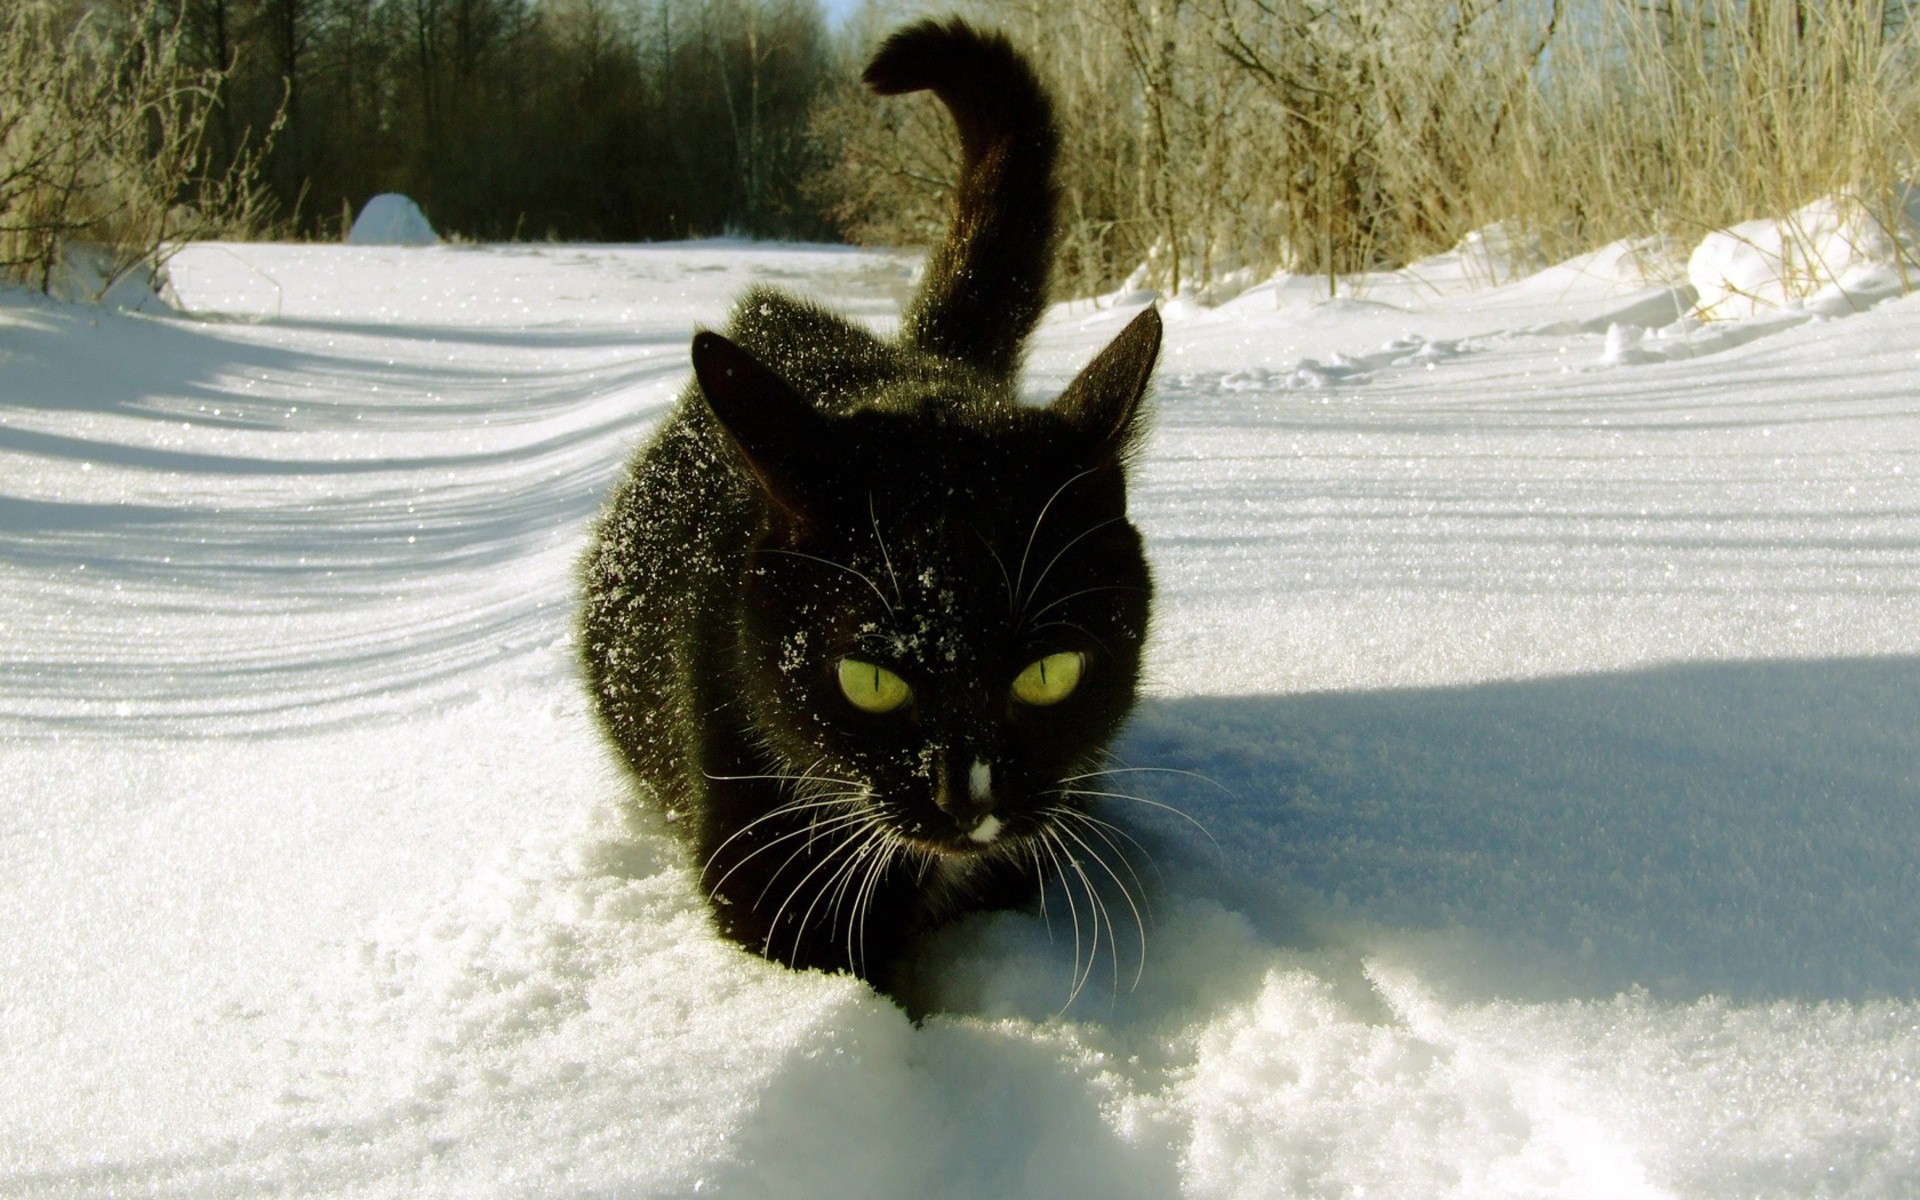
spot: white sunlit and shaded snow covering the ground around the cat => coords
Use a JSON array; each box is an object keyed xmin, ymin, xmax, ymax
[{"xmin": 0, "ymin": 244, "xmax": 1920, "ymax": 1200}]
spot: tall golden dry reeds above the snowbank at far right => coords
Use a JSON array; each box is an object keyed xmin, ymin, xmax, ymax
[{"xmin": 1497, "ymin": 0, "xmax": 1920, "ymax": 266}]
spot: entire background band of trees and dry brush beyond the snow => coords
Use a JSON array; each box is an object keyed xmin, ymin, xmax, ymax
[{"xmin": 11, "ymin": 0, "xmax": 1920, "ymax": 294}]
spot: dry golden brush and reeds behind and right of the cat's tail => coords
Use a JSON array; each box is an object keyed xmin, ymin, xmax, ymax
[{"xmin": 818, "ymin": 0, "xmax": 1920, "ymax": 294}]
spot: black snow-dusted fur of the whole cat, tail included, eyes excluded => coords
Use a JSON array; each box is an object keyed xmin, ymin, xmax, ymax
[{"xmin": 582, "ymin": 21, "xmax": 1160, "ymax": 996}]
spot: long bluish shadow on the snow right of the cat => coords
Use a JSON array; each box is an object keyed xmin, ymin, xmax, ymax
[{"xmin": 1121, "ymin": 657, "xmax": 1920, "ymax": 1000}]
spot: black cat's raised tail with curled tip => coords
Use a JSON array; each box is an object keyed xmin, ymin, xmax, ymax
[{"xmin": 862, "ymin": 17, "xmax": 1060, "ymax": 376}]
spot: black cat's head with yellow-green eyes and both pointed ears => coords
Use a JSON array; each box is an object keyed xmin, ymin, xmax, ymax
[{"xmin": 693, "ymin": 311, "xmax": 1160, "ymax": 856}]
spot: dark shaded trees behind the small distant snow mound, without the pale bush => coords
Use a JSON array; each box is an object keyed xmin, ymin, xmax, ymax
[{"xmin": 159, "ymin": 0, "xmax": 833, "ymax": 240}]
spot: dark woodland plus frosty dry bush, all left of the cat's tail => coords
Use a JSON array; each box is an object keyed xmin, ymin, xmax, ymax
[{"xmin": 0, "ymin": 0, "xmax": 841, "ymax": 290}]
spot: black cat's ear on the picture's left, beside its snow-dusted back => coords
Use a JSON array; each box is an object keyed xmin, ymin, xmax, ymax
[{"xmin": 693, "ymin": 330, "xmax": 826, "ymax": 518}]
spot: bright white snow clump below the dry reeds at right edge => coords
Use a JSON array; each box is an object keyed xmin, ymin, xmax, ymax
[{"xmin": 1688, "ymin": 184, "xmax": 1920, "ymax": 319}]
